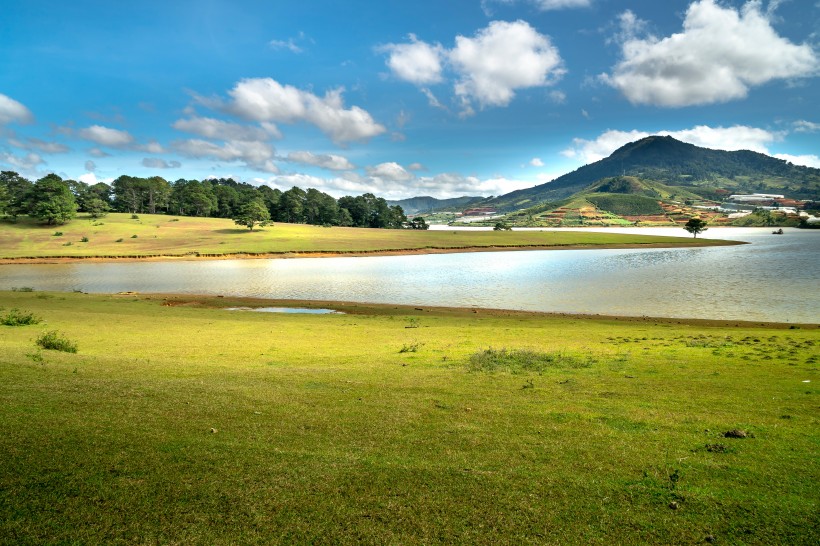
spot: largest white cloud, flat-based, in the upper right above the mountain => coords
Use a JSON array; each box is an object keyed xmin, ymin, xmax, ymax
[{"xmin": 602, "ymin": 0, "xmax": 820, "ymax": 107}]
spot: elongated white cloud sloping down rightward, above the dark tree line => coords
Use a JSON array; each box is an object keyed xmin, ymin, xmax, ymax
[{"xmin": 227, "ymin": 78, "xmax": 386, "ymax": 144}]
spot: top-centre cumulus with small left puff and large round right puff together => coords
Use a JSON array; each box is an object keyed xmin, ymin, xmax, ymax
[{"xmin": 381, "ymin": 20, "xmax": 566, "ymax": 115}]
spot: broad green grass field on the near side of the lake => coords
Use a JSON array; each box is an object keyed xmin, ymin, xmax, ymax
[{"xmin": 0, "ymin": 292, "xmax": 820, "ymax": 544}]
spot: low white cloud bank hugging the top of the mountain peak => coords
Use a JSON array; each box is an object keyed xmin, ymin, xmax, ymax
[{"xmin": 561, "ymin": 125, "xmax": 783, "ymax": 164}]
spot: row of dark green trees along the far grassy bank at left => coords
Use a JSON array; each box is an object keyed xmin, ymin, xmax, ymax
[{"xmin": 0, "ymin": 171, "xmax": 427, "ymax": 230}]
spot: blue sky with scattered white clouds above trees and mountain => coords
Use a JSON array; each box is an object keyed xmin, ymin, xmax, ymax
[{"xmin": 0, "ymin": 0, "xmax": 820, "ymax": 199}]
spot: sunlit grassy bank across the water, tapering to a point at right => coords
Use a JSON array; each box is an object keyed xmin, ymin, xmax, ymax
[{"xmin": 0, "ymin": 214, "xmax": 726, "ymax": 259}]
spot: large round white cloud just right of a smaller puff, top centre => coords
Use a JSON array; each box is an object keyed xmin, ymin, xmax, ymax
[{"xmin": 449, "ymin": 21, "xmax": 566, "ymax": 111}]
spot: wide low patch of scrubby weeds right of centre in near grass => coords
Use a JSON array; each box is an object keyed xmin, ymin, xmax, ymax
[{"xmin": 467, "ymin": 347, "xmax": 595, "ymax": 373}]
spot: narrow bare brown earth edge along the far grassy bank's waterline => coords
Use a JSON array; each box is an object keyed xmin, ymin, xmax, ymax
[{"xmin": 0, "ymin": 239, "xmax": 748, "ymax": 265}]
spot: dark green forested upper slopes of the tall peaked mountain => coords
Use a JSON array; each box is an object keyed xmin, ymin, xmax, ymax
[{"xmin": 482, "ymin": 136, "xmax": 820, "ymax": 210}]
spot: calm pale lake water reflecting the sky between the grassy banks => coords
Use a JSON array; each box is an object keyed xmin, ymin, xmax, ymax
[{"xmin": 0, "ymin": 228, "xmax": 820, "ymax": 323}]
